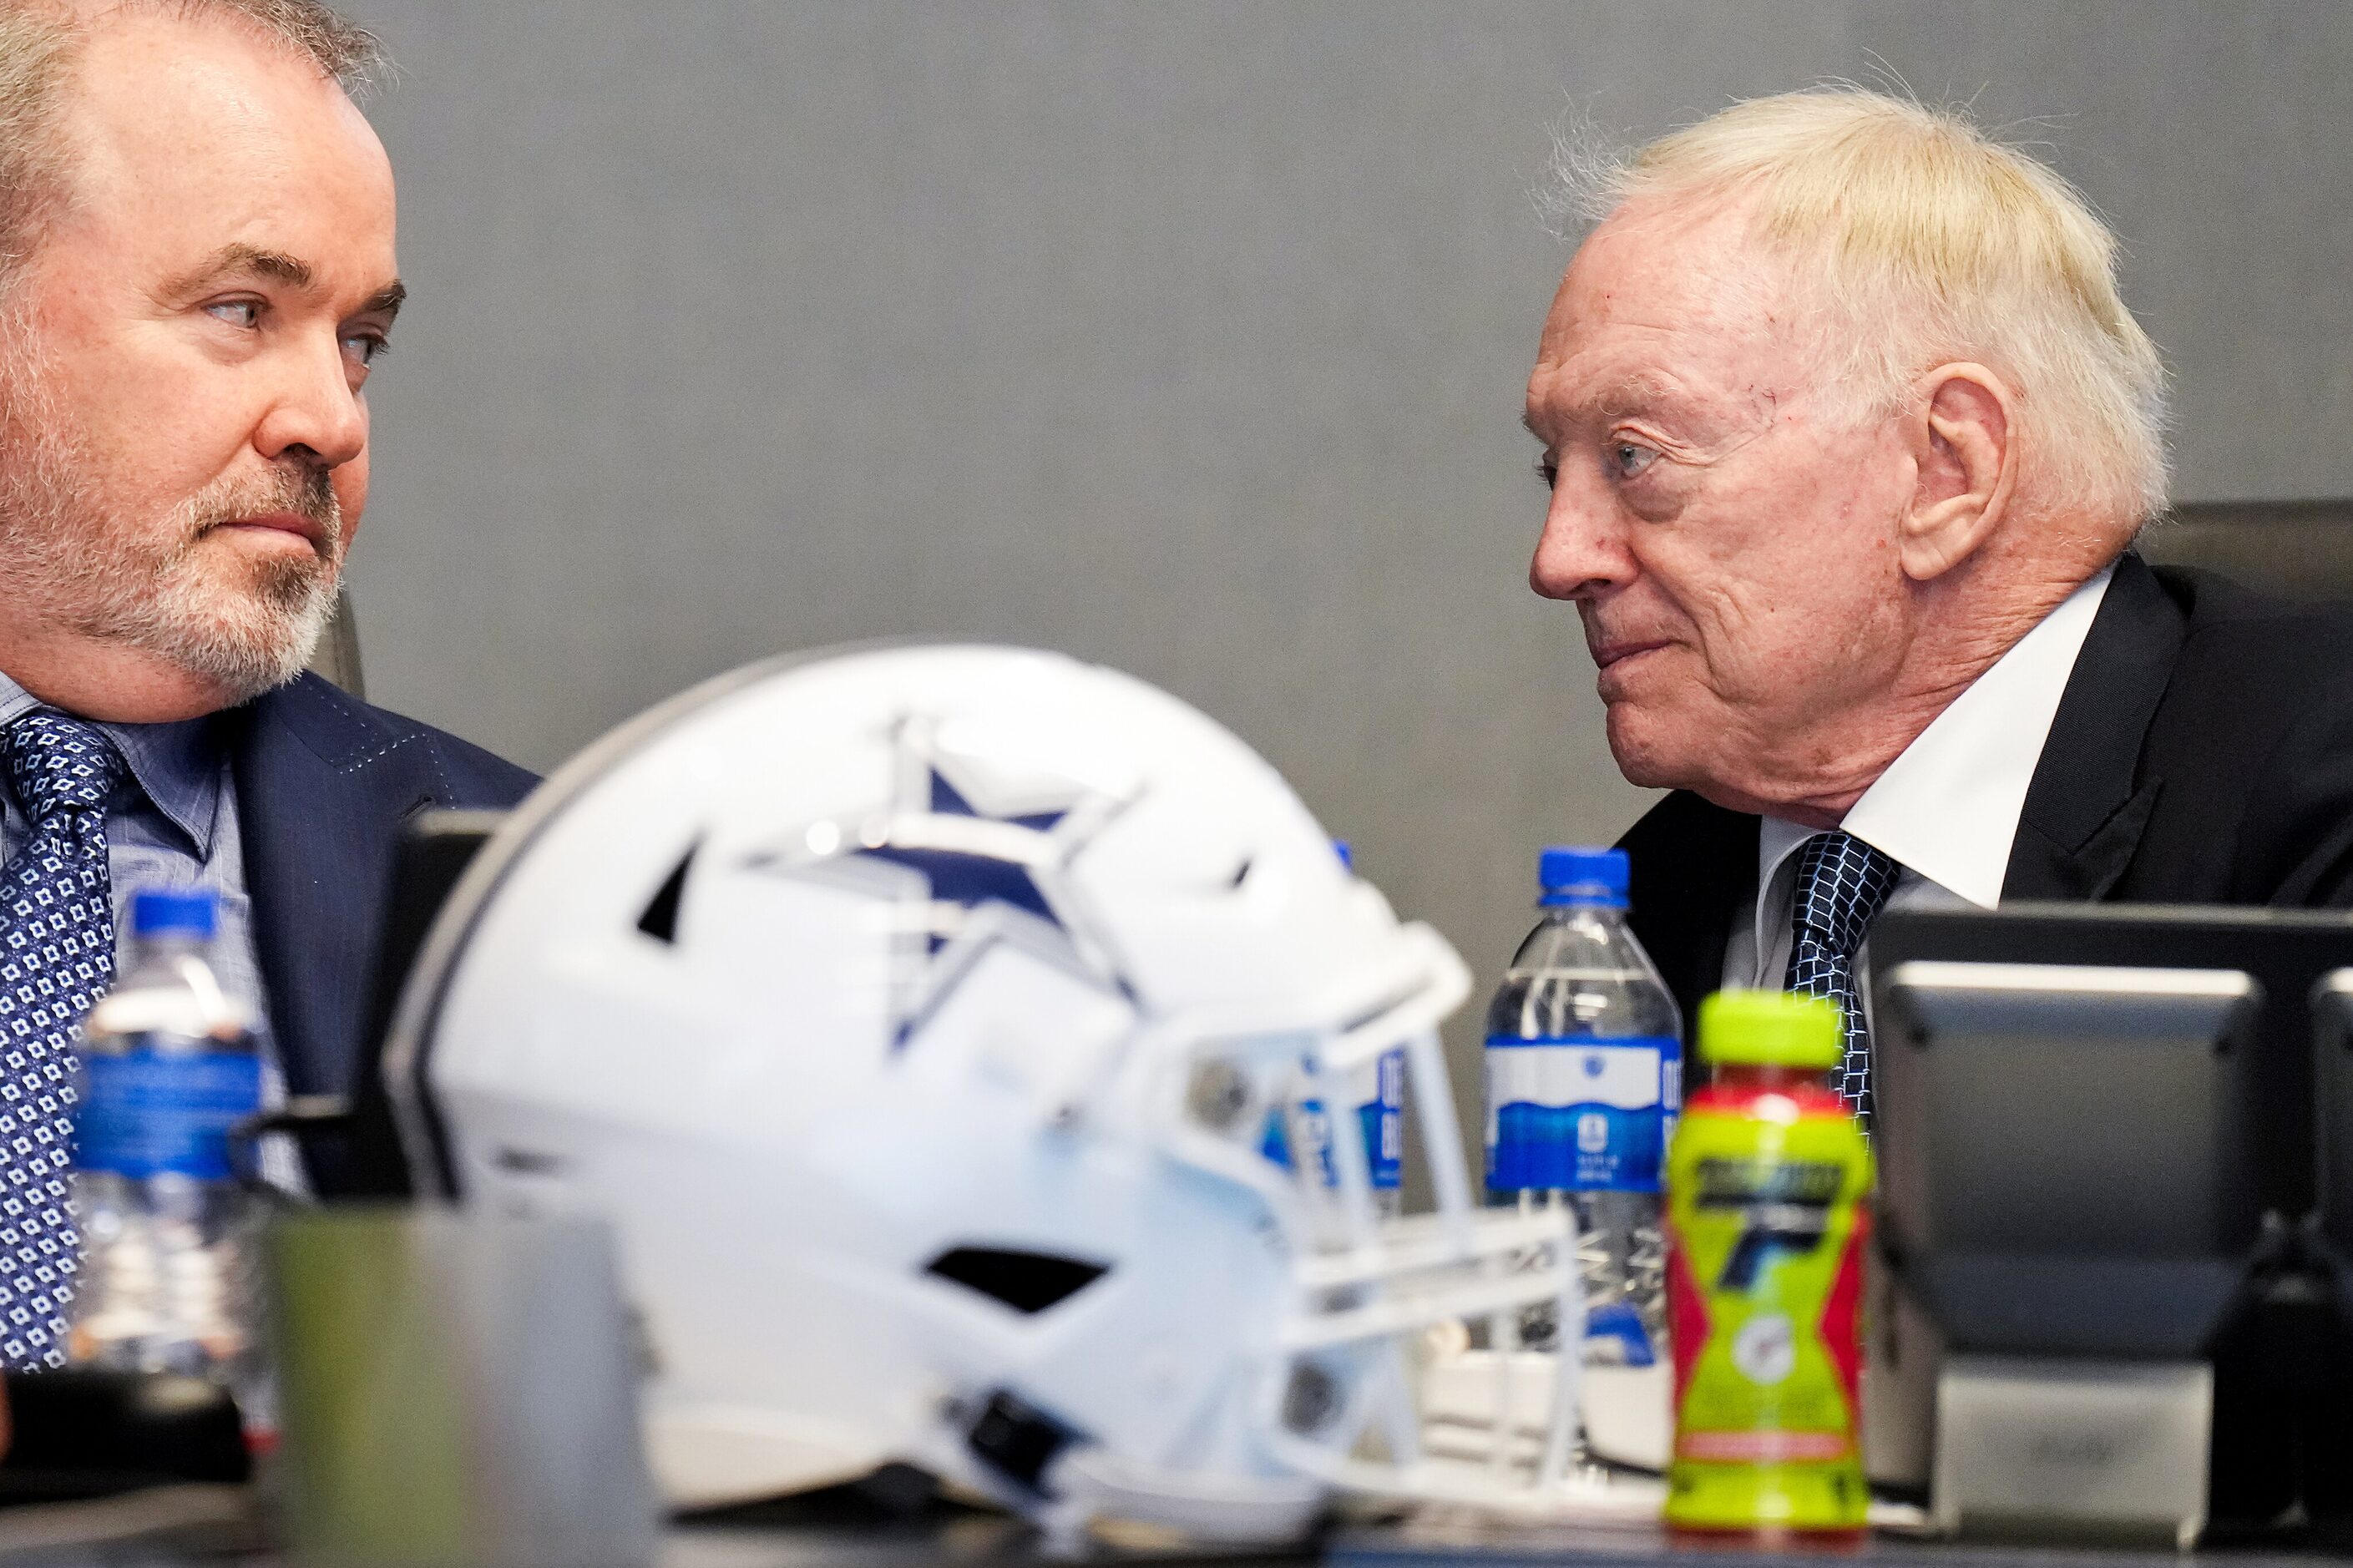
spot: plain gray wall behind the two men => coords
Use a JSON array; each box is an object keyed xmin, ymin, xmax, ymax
[{"xmin": 351, "ymin": 0, "xmax": 2353, "ymax": 1115}]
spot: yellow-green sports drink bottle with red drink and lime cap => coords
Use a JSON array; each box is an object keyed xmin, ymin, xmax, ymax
[{"xmin": 1666, "ymin": 991, "xmax": 1870, "ymax": 1535}]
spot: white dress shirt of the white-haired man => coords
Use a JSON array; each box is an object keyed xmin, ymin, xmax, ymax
[{"xmin": 1725, "ymin": 568, "xmax": 2113, "ymax": 989}]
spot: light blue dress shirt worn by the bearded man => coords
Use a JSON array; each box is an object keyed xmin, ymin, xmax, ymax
[{"xmin": 0, "ymin": 673, "xmax": 301, "ymax": 1191}]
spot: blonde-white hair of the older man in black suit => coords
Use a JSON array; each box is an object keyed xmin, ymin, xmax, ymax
[{"xmin": 1548, "ymin": 87, "xmax": 2167, "ymax": 525}]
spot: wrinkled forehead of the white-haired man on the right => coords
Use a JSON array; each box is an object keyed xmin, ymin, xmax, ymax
[{"xmin": 1530, "ymin": 203, "xmax": 1824, "ymax": 414}]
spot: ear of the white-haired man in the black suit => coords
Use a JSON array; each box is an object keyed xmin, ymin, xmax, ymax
[{"xmin": 1896, "ymin": 362, "xmax": 2019, "ymax": 581}]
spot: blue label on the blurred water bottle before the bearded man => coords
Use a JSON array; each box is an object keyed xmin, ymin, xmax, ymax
[{"xmin": 75, "ymin": 1050, "xmax": 261, "ymax": 1182}]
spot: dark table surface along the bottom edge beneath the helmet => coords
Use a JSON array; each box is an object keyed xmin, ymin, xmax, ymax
[{"xmin": 0, "ymin": 1485, "xmax": 2353, "ymax": 1568}]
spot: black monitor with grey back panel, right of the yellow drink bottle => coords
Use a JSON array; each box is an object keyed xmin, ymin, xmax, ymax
[{"xmin": 1870, "ymin": 904, "xmax": 2353, "ymax": 1521}]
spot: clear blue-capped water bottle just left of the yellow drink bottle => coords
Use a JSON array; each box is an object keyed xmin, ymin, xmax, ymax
[{"xmin": 1487, "ymin": 845, "xmax": 1683, "ymax": 1365}]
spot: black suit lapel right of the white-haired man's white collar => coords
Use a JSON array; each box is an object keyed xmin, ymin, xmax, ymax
[{"xmin": 2002, "ymin": 551, "xmax": 2183, "ymax": 902}]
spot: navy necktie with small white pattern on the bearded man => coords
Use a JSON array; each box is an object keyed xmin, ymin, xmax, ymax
[{"xmin": 0, "ymin": 709, "xmax": 123, "ymax": 1370}]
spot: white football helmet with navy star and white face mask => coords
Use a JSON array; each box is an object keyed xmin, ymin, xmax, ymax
[{"xmin": 386, "ymin": 645, "xmax": 1579, "ymax": 1540}]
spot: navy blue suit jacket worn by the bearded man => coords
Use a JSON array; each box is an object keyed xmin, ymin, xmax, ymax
[{"xmin": 221, "ymin": 673, "xmax": 537, "ymax": 1095}]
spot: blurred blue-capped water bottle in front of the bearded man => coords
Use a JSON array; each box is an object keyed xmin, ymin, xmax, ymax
[{"xmin": 68, "ymin": 893, "xmax": 268, "ymax": 1434}]
